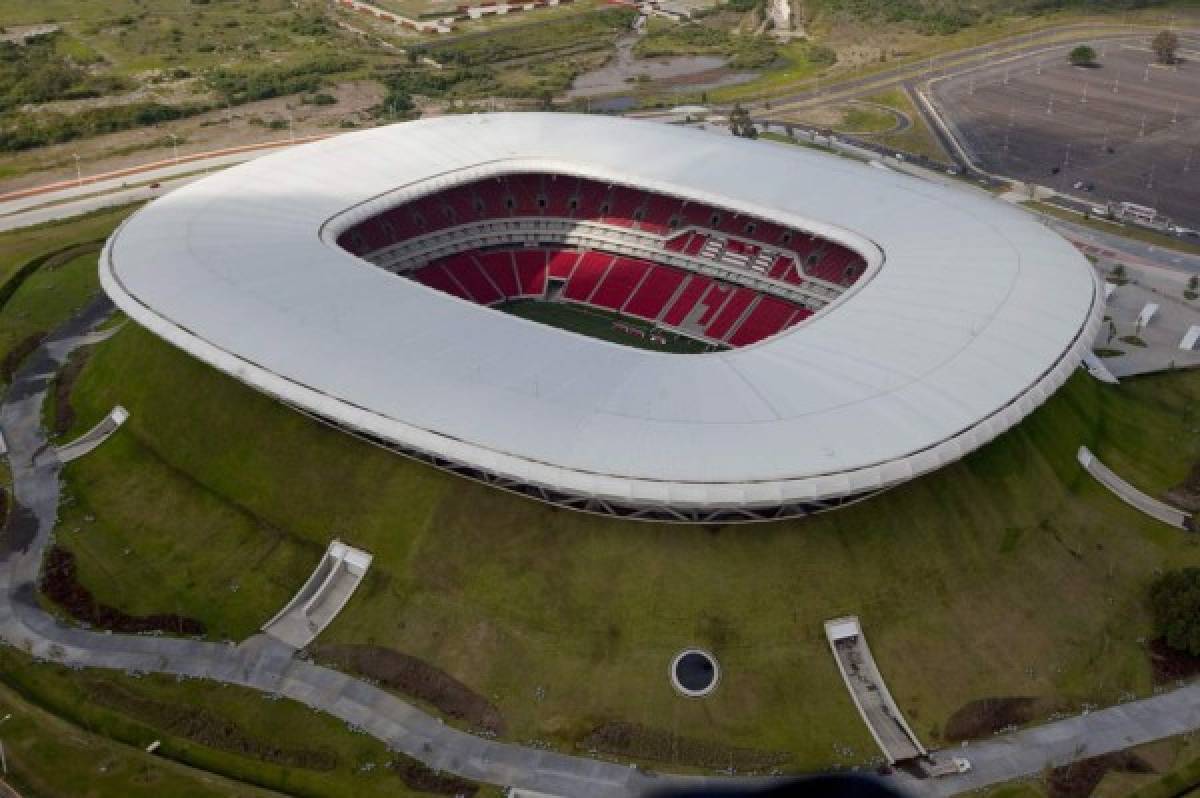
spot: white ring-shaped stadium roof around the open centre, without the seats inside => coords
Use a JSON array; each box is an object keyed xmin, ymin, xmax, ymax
[{"xmin": 101, "ymin": 114, "xmax": 1103, "ymax": 517}]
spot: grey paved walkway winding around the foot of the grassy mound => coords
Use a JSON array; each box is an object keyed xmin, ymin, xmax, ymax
[{"xmin": 0, "ymin": 298, "xmax": 1200, "ymax": 798}]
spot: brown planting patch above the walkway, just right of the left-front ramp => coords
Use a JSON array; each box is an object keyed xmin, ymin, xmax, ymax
[{"xmin": 311, "ymin": 643, "xmax": 504, "ymax": 734}]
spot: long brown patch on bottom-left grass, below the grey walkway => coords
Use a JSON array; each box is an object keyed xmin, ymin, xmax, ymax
[{"xmin": 86, "ymin": 680, "xmax": 337, "ymax": 770}]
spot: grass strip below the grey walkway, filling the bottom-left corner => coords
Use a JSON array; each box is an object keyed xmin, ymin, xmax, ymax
[{"xmin": 0, "ymin": 648, "xmax": 499, "ymax": 798}]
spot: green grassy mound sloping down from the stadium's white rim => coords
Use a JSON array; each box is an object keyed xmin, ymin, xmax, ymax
[{"xmin": 54, "ymin": 314, "xmax": 1200, "ymax": 768}]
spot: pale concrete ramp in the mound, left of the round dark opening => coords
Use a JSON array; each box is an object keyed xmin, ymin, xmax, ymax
[{"xmin": 262, "ymin": 539, "xmax": 372, "ymax": 648}]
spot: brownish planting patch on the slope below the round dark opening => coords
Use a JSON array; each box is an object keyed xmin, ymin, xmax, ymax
[{"xmin": 580, "ymin": 721, "xmax": 788, "ymax": 773}]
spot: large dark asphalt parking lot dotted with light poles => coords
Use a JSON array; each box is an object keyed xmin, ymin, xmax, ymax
[{"xmin": 932, "ymin": 34, "xmax": 1200, "ymax": 228}]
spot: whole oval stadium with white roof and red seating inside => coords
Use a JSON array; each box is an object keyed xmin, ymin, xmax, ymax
[{"xmin": 101, "ymin": 114, "xmax": 1103, "ymax": 522}]
